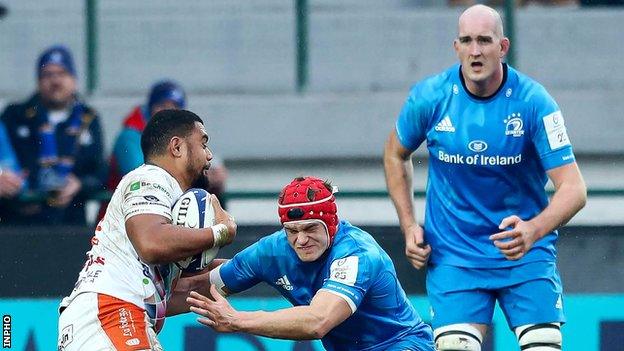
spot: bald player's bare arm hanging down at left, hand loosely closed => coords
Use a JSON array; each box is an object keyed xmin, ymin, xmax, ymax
[{"xmin": 384, "ymin": 131, "xmax": 431, "ymax": 269}]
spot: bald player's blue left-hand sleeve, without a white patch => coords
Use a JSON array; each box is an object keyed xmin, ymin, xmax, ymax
[{"xmin": 395, "ymin": 89, "xmax": 430, "ymax": 151}]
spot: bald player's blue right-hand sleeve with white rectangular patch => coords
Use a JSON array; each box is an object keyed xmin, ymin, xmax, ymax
[{"xmin": 531, "ymin": 88, "xmax": 575, "ymax": 170}]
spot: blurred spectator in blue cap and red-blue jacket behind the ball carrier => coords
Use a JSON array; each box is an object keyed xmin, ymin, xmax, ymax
[{"xmin": 105, "ymin": 80, "xmax": 227, "ymax": 212}]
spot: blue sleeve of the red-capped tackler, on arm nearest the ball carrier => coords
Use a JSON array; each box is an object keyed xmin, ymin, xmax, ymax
[{"xmin": 210, "ymin": 241, "xmax": 263, "ymax": 294}]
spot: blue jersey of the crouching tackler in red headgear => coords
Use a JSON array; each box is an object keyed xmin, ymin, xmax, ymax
[{"xmin": 219, "ymin": 221, "xmax": 432, "ymax": 350}]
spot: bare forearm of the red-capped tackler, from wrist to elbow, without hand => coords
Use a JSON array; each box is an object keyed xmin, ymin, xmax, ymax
[{"xmin": 234, "ymin": 306, "xmax": 326, "ymax": 340}]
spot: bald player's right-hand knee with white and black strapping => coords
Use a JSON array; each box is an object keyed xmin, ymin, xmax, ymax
[{"xmin": 516, "ymin": 323, "xmax": 562, "ymax": 351}]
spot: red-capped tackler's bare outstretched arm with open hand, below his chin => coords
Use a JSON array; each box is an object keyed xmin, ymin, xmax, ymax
[{"xmin": 187, "ymin": 285, "xmax": 352, "ymax": 340}]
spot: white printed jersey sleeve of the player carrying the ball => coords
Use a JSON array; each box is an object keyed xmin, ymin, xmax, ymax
[{"xmin": 122, "ymin": 173, "xmax": 176, "ymax": 221}]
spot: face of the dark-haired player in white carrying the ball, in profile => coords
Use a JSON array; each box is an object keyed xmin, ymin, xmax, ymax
[{"xmin": 186, "ymin": 122, "xmax": 212, "ymax": 188}]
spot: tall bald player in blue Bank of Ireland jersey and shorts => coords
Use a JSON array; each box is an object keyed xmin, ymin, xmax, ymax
[{"xmin": 384, "ymin": 5, "xmax": 586, "ymax": 351}]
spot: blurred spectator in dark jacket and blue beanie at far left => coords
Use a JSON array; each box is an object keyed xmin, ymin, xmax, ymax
[{"xmin": 0, "ymin": 45, "xmax": 106, "ymax": 224}]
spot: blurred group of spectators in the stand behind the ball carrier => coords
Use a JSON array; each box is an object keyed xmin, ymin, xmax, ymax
[{"xmin": 0, "ymin": 45, "xmax": 227, "ymax": 225}]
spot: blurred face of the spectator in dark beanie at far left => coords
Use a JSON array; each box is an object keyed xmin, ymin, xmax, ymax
[{"xmin": 39, "ymin": 64, "xmax": 76, "ymax": 109}]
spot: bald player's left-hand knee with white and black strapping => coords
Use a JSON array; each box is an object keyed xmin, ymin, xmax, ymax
[{"xmin": 433, "ymin": 323, "xmax": 483, "ymax": 351}]
